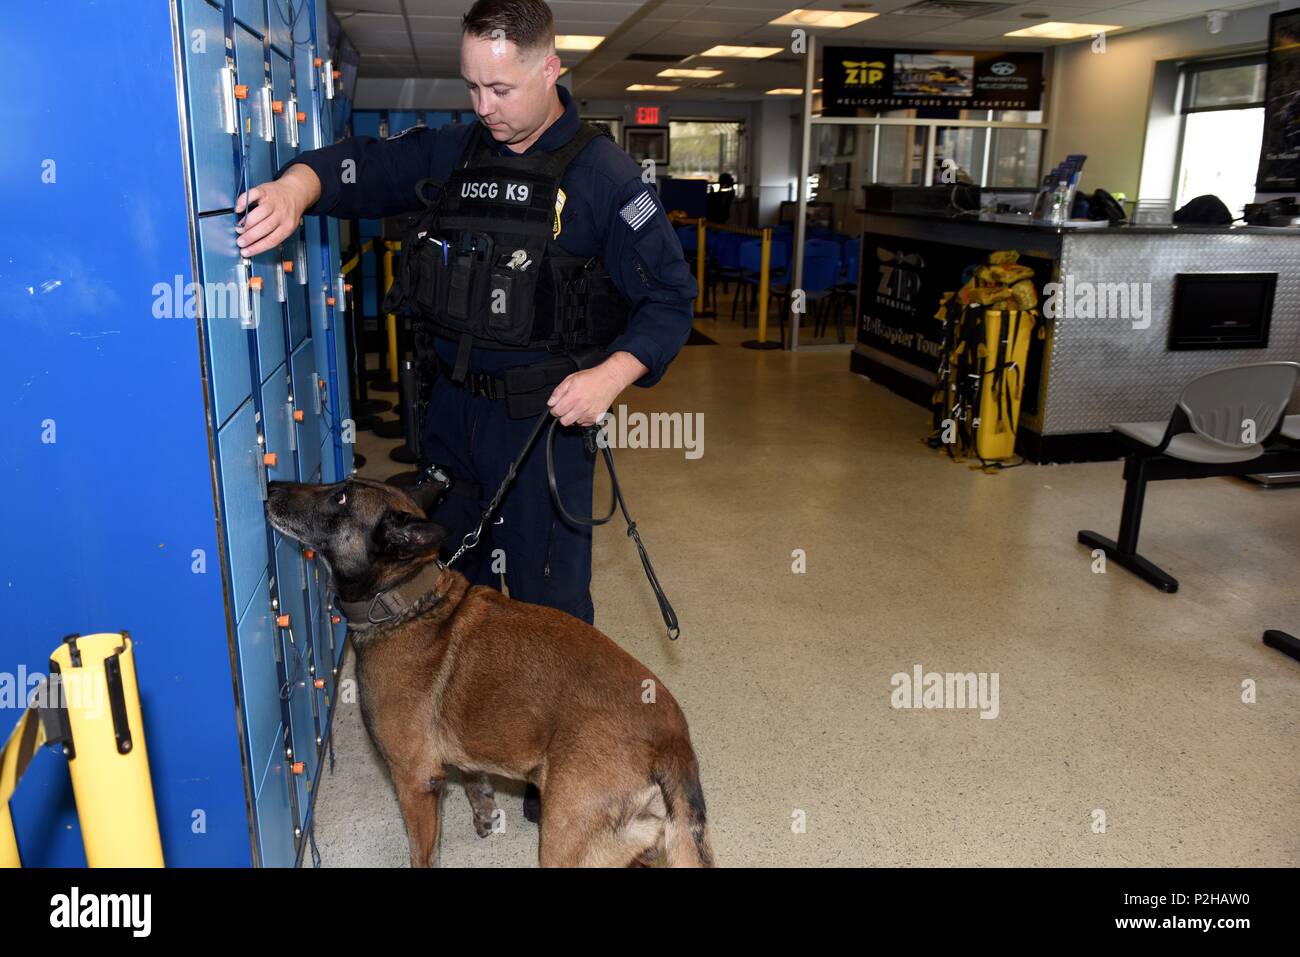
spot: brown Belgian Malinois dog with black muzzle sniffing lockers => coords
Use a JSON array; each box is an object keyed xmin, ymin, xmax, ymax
[{"xmin": 267, "ymin": 479, "xmax": 712, "ymax": 867}]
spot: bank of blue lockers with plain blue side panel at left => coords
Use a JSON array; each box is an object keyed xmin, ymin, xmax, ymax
[{"xmin": 0, "ymin": 0, "xmax": 352, "ymax": 866}]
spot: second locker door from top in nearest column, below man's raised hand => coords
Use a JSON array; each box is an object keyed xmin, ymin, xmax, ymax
[{"xmin": 199, "ymin": 215, "xmax": 254, "ymax": 426}]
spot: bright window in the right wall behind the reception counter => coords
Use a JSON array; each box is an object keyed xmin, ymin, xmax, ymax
[{"xmin": 1174, "ymin": 56, "xmax": 1265, "ymax": 216}]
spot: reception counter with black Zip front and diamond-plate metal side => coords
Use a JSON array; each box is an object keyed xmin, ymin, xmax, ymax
[{"xmin": 850, "ymin": 212, "xmax": 1300, "ymax": 462}]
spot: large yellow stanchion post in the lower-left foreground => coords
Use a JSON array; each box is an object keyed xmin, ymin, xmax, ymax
[{"xmin": 49, "ymin": 632, "xmax": 163, "ymax": 867}]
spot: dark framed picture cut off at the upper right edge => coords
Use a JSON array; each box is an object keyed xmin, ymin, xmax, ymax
[{"xmin": 1255, "ymin": 9, "xmax": 1300, "ymax": 192}]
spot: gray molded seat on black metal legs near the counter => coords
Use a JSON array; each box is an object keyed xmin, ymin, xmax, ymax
[{"xmin": 1079, "ymin": 363, "xmax": 1300, "ymax": 592}]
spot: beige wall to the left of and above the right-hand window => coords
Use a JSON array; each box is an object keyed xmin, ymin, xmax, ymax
[{"xmin": 1044, "ymin": 3, "xmax": 1278, "ymax": 199}]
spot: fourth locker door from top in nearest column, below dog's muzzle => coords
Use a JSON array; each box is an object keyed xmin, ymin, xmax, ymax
[{"xmin": 237, "ymin": 570, "xmax": 282, "ymax": 821}]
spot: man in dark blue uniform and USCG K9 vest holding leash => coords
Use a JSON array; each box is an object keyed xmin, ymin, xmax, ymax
[{"xmin": 235, "ymin": 0, "xmax": 697, "ymax": 819}]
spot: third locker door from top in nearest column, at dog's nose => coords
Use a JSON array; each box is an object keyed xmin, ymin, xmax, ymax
[{"xmin": 217, "ymin": 400, "xmax": 270, "ymax": 616}]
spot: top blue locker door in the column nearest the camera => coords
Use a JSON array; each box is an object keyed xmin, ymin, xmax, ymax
[{"xmin": 181, "ymin": 0, "xmax": 237, "ymax": 213}]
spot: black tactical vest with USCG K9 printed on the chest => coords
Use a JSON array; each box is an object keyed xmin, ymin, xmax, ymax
[{"xmin": 384, "ymin": 122, "xmax": 628, "ymax": 367}]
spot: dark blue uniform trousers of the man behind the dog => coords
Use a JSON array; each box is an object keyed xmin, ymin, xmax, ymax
[{"xmin": 421, "ymin": 350, "xmax": 595, "ymax": 624}]
